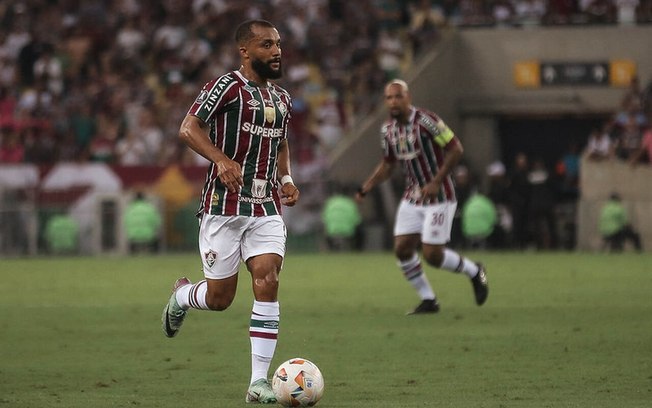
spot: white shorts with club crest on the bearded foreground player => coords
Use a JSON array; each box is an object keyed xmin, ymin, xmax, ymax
[{"xmin": 199, "ymin": 214, "xmax": 287, "ymax": 279}]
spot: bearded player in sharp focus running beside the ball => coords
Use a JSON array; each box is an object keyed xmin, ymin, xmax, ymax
[{"xmin": 162, "ymin": 20, "xmax": 299, "ymax": 404}]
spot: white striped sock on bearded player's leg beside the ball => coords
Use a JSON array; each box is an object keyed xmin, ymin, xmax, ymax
[{"xmin": 249, "ymin": 300, "xmax": 280, "ymax": 383}]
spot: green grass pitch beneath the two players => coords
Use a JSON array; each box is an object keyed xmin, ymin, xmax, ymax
[{"xmin": 0, "ymin": 252, "xmax": 652, "ymax": 408}]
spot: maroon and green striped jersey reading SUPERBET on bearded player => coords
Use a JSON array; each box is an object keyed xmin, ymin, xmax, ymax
[{"xmin": 188, "ymin": 71, "xmax": 292, "ymax": 217}]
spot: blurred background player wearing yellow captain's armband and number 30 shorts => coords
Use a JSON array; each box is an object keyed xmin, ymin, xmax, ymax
[{"xmin": 356, "ymin": 80, "xmax": 489, "ymax": 314}]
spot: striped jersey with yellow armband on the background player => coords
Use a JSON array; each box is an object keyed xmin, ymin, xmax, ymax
[{"xmin": 381, "ymin": 107, "xmax": 457, "ymax": 204}]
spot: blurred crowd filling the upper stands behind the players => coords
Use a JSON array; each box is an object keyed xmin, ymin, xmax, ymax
[{"xmin": 0, "ymin": 0, "xmax": 652, "ymax": 166}]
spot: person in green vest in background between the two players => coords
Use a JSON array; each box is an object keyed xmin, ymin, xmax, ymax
[{"xmin": 321, "ymin": 186, "xmax": 362, "ymax": 251}]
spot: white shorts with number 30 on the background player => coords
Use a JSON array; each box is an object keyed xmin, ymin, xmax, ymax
[{"xmin": 394, "ymin": 200, "xmax": 457, "ymax": 245}]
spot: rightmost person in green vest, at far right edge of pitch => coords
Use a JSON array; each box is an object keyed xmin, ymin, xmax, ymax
[{"xmin": 598, "ymin": 193, "xmax": 643, "ymax": 252}]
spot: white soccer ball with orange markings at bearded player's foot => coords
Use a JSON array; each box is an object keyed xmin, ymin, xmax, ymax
[{"xmin": 272, "ymin": 358, "xmax": 324, "ymax": 407}]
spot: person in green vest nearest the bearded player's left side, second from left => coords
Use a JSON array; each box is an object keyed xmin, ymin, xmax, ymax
[{"xmin": 124, "ymin": 191, "xmax": 162, "ymax": 253}]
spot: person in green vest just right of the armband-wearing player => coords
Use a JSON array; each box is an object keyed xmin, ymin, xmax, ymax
[{"xmin": 462, "ymin": 193, "xmax": 498, "ymax": 247}]
